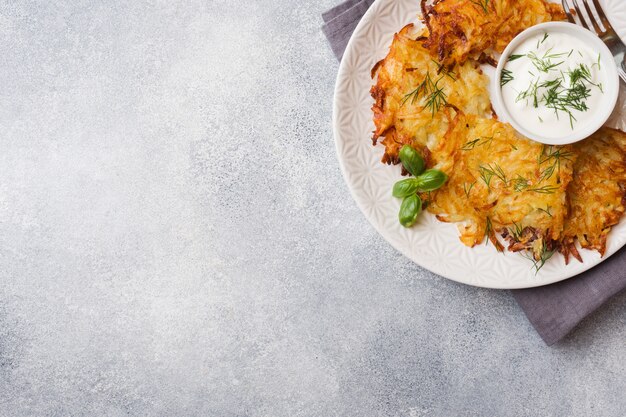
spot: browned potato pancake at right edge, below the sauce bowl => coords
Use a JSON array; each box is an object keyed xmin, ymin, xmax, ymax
[{"xmin": 561, "ymin": 127, "xmax": 626, "ymax": 262}]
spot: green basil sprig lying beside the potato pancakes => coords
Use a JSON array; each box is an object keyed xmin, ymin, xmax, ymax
[{"xmin": 392, "ymin": 145, "xmax": 448, "ymax": 227}]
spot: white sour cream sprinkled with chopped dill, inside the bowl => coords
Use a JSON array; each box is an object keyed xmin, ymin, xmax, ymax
[{"xmin": 500, "ymin": 31, "xmax": 610, "ymax": 139}]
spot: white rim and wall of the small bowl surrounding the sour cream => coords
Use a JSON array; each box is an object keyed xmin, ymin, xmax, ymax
[{"xmin": 492, "ymin": 22, "xmax": 619, "ymax": 145}]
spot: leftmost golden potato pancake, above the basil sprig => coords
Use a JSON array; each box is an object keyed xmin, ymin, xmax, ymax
[{"xmin": 371, "ymin": 25, "xmax": 491, "ymax": 164}]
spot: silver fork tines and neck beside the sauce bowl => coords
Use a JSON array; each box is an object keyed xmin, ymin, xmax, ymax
[{"xmin": 561, "ymin": 0, "xmax": 626, "ymax": 83}]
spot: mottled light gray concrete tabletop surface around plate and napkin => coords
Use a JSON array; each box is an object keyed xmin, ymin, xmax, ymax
[{"xmin": 0, "ymin": 0, "xmax": 626, "ymax": 417}]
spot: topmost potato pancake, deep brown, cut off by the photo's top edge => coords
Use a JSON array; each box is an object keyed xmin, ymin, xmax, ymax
[{"xmin": 421, "ymin": 0, "xmax": 566, "ymax": 65}]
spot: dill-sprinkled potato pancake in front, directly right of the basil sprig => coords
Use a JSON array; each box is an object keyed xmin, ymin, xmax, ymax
[{"xmin": 424, "ymin": 114, "xmax": 574, "ymax": 256}]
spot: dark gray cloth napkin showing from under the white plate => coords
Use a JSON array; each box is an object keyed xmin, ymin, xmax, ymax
[{"xmin": 322, "ymin": 0, "xmax": 626, "ymax": 345}]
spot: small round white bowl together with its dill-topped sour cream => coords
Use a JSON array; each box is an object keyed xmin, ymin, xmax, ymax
[{"xmin": 491, "ymin": 22, "xmax": 619, "ymax": 145}]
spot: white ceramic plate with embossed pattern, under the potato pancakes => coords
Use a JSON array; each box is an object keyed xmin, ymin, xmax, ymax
[{"xmin": 333, "ymin": 0, "xmax": 626, "ymax": 288}]
